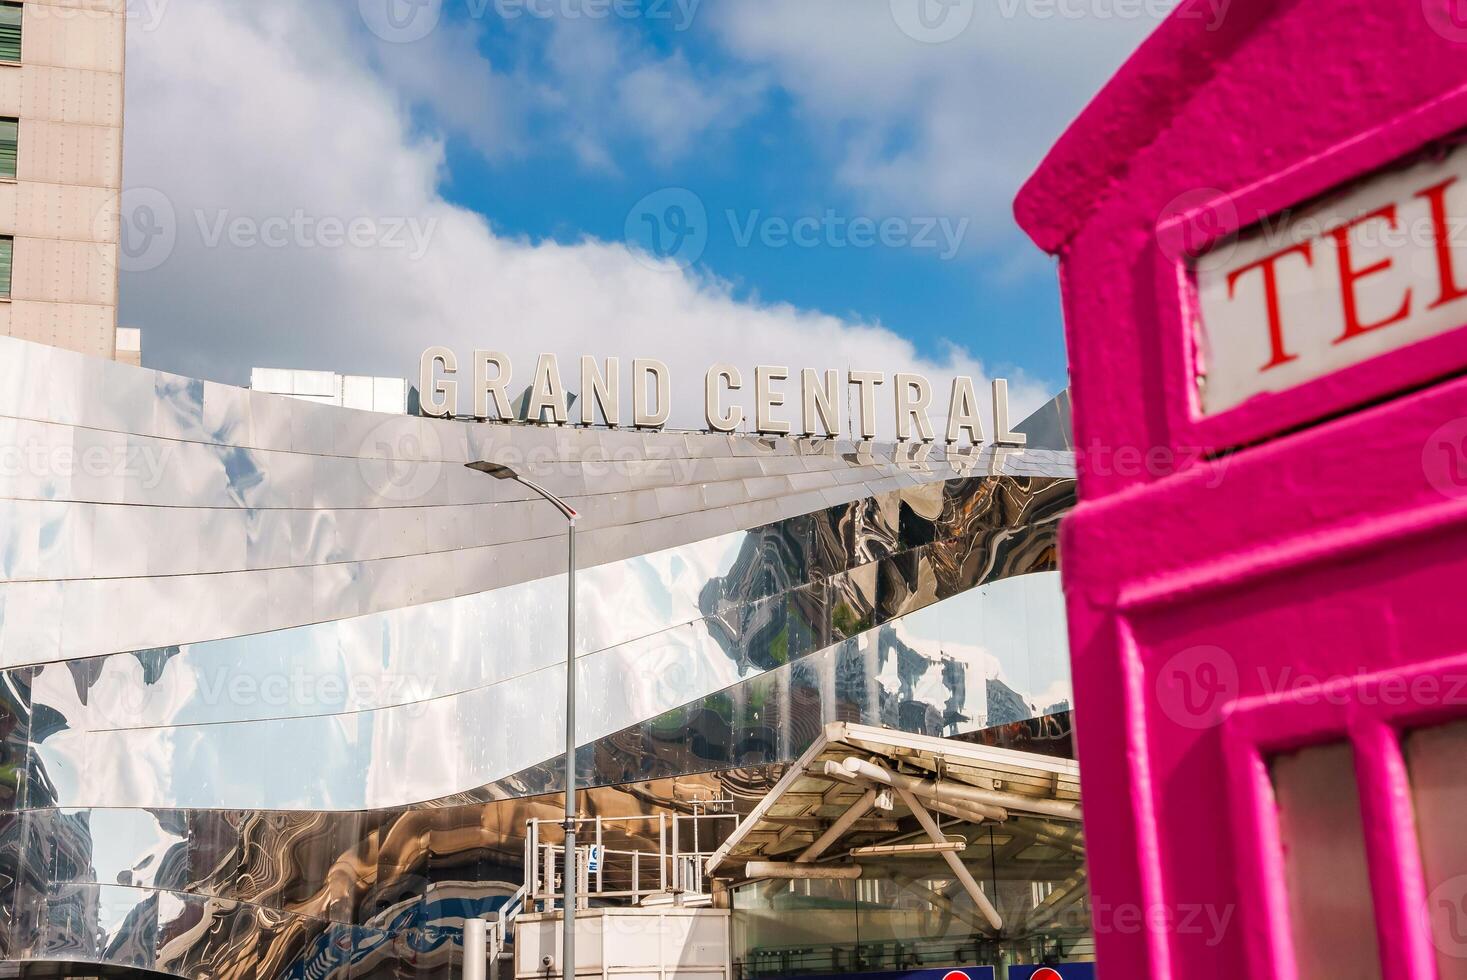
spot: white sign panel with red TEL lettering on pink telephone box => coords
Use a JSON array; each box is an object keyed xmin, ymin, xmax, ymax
[{"xmin": 1194, "ymin": 148, "xmax": 1467, "ymax": 415}]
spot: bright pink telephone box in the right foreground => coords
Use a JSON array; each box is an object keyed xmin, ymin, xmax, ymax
[{"xmin": 1017, "ymin": 0, "xmax": 1467, "ymax": 980}]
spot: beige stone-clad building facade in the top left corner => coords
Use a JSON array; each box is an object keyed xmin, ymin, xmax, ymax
[{"xmin": 0, "ymin": 0, "xmax": 123, "ymax": 362}]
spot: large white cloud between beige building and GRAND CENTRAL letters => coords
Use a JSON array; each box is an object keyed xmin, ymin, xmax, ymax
[{"xmin": 123, "ymin": 0, "xmax": 1058, "ymax": 437}]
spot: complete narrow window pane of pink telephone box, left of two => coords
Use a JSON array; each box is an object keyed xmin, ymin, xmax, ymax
[{"xmin": 1272, "ymin": 742, "xmax": 1380, "ymax": 980}]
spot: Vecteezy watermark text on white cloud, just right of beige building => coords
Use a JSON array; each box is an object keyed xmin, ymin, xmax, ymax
[{"xmin": 194, "ymin": 208, "xmax": 439, "ymax": 261}]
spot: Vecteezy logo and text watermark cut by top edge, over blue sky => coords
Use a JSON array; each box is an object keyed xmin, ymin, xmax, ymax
[{"xmin": 358, "ymin": 0, "xmax": 703, "ymax": 44}]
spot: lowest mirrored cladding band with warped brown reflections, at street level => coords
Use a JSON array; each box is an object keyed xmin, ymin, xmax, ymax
[{"xmin": 0, "ymin": 718, "xmax": 1072, "ymax": 980}]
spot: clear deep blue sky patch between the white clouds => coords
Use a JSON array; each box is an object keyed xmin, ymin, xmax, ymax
[{"xmin": 428, "ymin": 7, "xmax": 1083, "ymax": 379}]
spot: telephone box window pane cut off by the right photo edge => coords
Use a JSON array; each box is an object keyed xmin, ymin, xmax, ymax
[{"xmin": 1405, "ymin": 722, "xmax": 1467, "ymax": 980}]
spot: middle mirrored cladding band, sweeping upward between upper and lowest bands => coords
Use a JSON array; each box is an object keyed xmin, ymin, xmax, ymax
[{"xmin": 22, "ymin": 478, "xmax": 1068, "ymax": 810}]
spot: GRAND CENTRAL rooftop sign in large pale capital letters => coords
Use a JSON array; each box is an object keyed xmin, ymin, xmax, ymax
[{"xmin": 418, "ymin": 348, "xmax": 1025, "ymax": 446}]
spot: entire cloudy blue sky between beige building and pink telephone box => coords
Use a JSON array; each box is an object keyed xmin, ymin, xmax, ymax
[{"xmin": 122, "ymin": 0, "xmax": 1169, "ymax": 425}]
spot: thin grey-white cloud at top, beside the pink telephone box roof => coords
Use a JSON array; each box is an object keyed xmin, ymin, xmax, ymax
[{"xmin": 704, "ymin": 0, "xmax": 1173, "ymax": 239}]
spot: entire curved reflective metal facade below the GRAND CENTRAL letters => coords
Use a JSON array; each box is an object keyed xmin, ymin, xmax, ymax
[{"xmin": 0, "ymin": 337, "xmax": 1072, "ymax": 979}]
